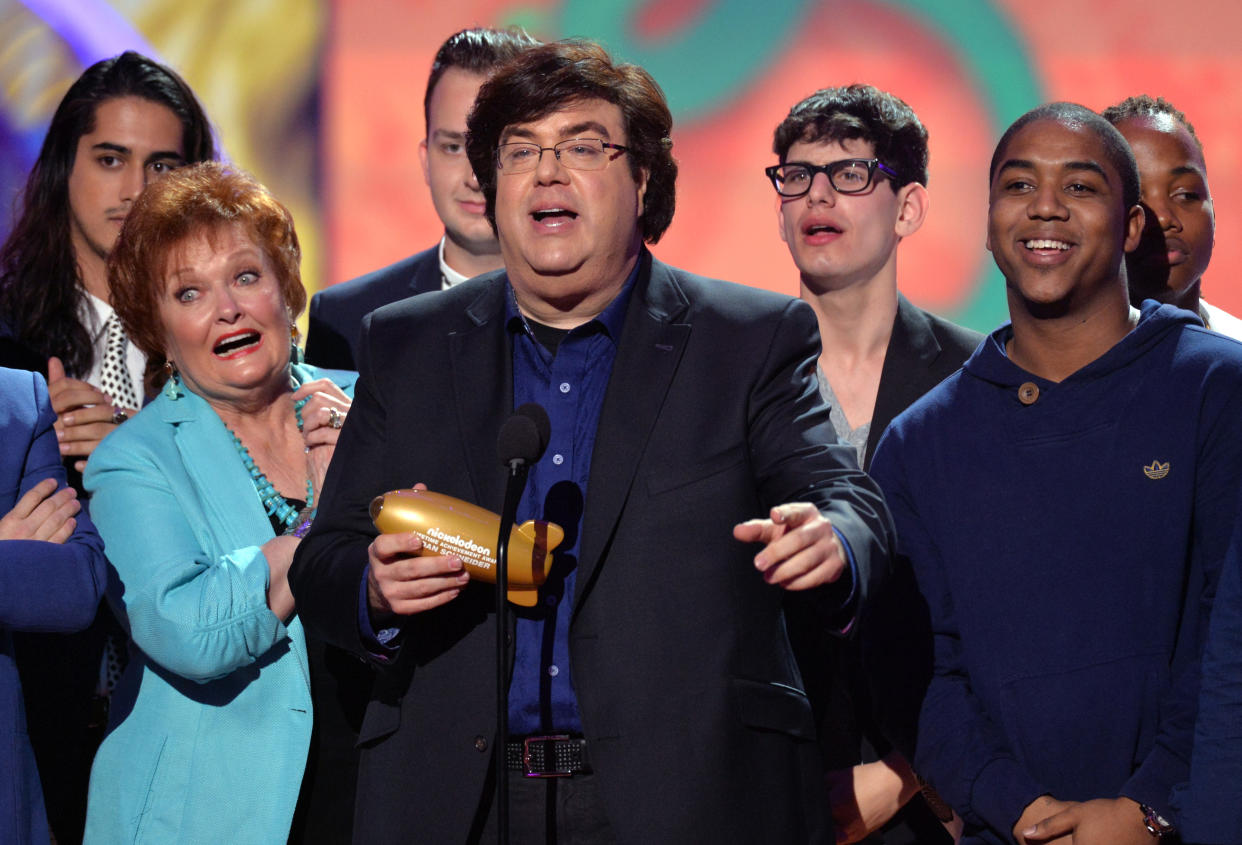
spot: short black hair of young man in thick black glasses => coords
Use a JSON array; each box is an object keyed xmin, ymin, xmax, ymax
[{"xmin": 773, "ymin": 83, "xmax": 928, "ymax": 191}]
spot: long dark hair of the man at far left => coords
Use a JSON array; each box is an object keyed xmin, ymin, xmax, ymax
[{"xmin": 0, "ymin": 51, "xmax": 215, "ymax": 377}]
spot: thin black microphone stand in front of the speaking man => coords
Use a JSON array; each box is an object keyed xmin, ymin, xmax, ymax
[{"xmin": 494, "ymin": 457, "xmax": 530, "ymax": 845}]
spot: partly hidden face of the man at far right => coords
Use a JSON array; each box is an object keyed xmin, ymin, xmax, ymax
[{"xmin": 1117, "ymin": 114, "xmax": 1216, "ymax": 309}]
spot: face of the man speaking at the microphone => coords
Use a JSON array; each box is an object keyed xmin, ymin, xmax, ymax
[{"xmin": 496, "ymin": 99, "xmax": 646, "ymax": 328}]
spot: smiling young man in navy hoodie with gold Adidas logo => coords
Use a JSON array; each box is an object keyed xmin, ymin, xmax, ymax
[{"xmin": 872, "ymin": 103, "xmax": 1242, "ymax": 845}]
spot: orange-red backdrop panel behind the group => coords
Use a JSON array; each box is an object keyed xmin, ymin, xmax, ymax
[{"xmin": 322, "ymin": 0, "xmax": 1242, "ymax": 329}]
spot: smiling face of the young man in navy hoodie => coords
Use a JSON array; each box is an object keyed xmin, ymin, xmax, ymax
[{"xmin": 987, "ymin": 119, "xmax": 1143, "ymax": 317}]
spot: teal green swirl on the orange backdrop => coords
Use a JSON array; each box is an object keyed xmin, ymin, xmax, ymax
[{"xmin": 510, "ymin": 0, "xmax": 1043, "ymax": 331}]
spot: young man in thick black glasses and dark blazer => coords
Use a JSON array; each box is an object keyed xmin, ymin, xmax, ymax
[{"xmin": 766, "ymin": 85, "xmax": 982, "ymax": 844}]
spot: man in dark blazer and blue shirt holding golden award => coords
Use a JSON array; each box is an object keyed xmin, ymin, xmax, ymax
[{"xmin": 289, "ymin": 41, "xmax": 891, "ymax": 843}]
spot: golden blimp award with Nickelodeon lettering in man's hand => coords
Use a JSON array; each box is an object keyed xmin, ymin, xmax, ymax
[{"xmin": 371, "ymin": 490, "xmax": 565, "ymax": 608}]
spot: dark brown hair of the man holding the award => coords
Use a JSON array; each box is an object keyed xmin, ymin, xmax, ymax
[{"xmin": 466, "ymin": 39, "xmax": 677, "ymax": 244}]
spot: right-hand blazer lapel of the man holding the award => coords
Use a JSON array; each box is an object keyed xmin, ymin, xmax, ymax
[{"xmin": 574, "ymin": 251, "xmax": 691, "ymax": 613}]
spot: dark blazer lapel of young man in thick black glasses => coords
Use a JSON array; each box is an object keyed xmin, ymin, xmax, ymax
[{"xmin": 863, "ymin": 293, "xmax": 940, "ymax": 470}]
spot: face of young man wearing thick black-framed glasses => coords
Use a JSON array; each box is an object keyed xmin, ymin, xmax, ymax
[{"xmin": 776, "ymin": 138, "xmax": 924, "ymax": 293}]
